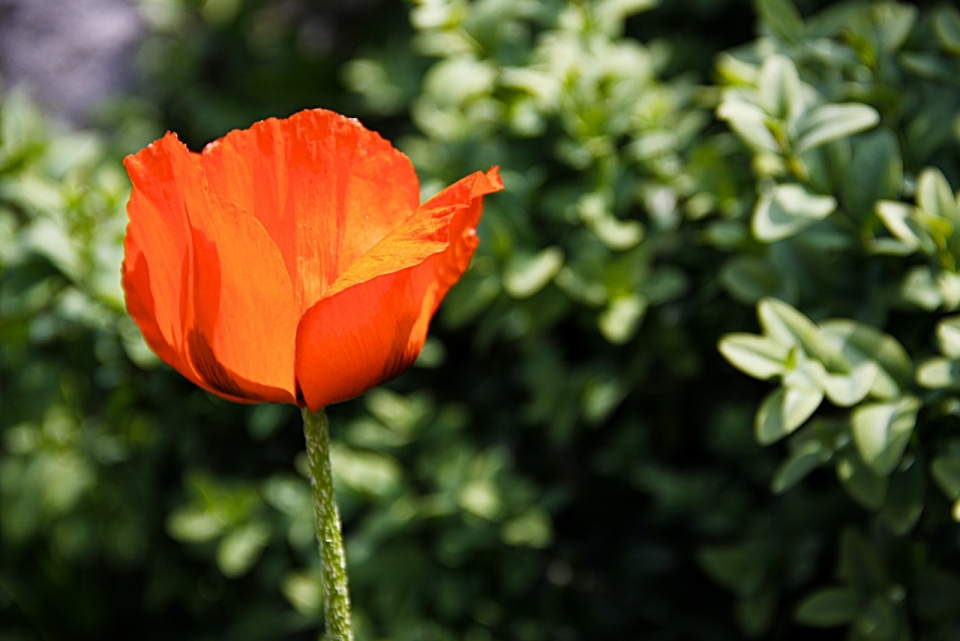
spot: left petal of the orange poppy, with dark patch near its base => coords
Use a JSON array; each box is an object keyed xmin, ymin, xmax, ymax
[{"xmin": 123, "ymin": 134, "xmax": 298, "ymax": 402}]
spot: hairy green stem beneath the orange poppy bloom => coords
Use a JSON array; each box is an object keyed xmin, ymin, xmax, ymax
[{"xmin": 303, "ymin": 408, "xmax": 353, "ymax": 641}]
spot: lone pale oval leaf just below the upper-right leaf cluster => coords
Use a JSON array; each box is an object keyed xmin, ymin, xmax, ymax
[{"xmin": 752, "ymin": 184, "xmax": 837, "ymax": 243}]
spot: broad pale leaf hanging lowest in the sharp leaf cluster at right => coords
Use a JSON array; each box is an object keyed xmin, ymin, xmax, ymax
[{"xmin": 852, "ymin": 396, "xmax": 920, "ymax": 476}]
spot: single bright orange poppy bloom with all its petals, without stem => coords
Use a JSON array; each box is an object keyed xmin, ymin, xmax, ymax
[{"xmin": 123, "ymin": 109, "xmax": 503, "ymax": 411}]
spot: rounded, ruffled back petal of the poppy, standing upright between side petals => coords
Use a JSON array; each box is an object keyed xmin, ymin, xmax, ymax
[{"xmin": 201, "ymin": 109, "xmax": 420, "ymax": 314}]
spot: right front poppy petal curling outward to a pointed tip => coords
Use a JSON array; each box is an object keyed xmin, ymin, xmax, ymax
[{"xmin": 296, "ymin": 168, "xmax": 502, "ymax": 411}]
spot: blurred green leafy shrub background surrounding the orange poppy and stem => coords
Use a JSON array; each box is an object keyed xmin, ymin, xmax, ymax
[{"xmin": 0, "ymin": 0, "xmax": 960, "ymax": 641}]
